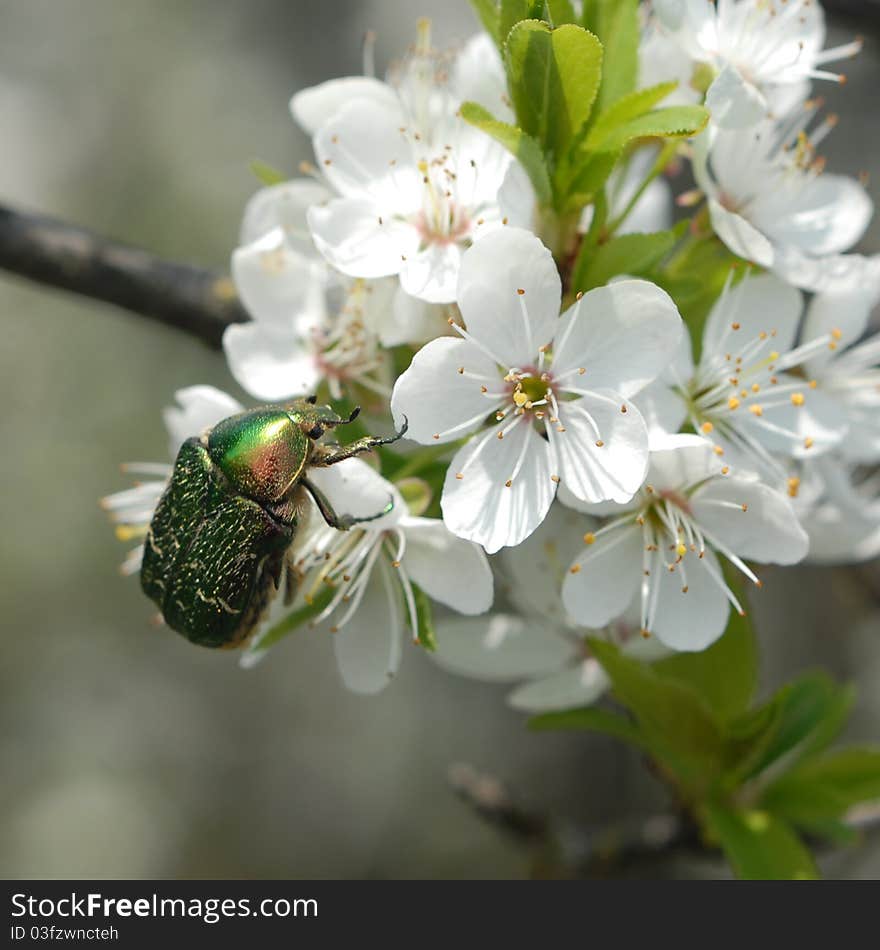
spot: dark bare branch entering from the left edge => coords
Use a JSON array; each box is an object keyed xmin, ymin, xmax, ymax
[{"xmin": 0, "ymin": 205, "xmax": 248, "ymax": 348}]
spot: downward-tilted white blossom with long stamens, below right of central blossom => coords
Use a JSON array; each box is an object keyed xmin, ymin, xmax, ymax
[{"xmin": 562, "ymin": 435, "xmax": 808, "ymax": 650}]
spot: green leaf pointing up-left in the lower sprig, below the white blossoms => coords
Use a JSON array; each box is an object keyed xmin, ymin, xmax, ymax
[{"xmin": 589, "ymin": 639, "xmax": 724, "ymax": 789}]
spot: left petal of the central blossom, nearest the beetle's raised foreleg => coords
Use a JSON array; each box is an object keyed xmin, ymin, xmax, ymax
[{"xmin": 391, "ymin": 337, "xmax": 502, "ymax": 445}]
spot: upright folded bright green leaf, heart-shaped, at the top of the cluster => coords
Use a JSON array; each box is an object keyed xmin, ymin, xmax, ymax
[{"xmin": 505, "ymin": 20, "xmax": 602, "ymax": 164}]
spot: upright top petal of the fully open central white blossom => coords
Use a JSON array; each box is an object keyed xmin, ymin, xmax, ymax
[{"xmin": 458, "ymin": 227, "xmax": 562, "ymax": 367}]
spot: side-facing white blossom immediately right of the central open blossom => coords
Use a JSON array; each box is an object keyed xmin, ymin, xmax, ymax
[{"xmin": 636, "ymin": 274, "xmax": 846, "ymax": 489}]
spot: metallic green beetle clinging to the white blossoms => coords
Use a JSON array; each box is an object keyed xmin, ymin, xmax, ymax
[{"xmin": 141, "ymin": 398, "xmax": 406, "ymax": 647}]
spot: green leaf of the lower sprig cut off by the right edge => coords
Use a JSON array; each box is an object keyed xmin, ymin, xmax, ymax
[{"xmin": 761, "ymin": 746, "xmax": 880, "ymax": 829}]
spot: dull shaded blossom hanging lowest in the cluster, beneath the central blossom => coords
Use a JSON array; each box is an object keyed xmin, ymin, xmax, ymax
[{"xmin": 431, "ymin": 505, "xmax": 663, "ymax": 712}]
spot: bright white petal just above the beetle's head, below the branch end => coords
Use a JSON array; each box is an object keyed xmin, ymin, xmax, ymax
[{"xmin": 223, "ymin": 323, "xmax": 320, "ymax": 402}]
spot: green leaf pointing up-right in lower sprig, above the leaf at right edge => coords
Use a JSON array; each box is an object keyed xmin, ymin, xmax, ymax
[{"xmin": 736, "ymin": 671, "xmax": 855, "ymax": 779}]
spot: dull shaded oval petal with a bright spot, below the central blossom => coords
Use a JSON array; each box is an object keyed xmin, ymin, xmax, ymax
[{"xmin": 431, "ymin": 614, "xmax": 577, "ymax": 682}]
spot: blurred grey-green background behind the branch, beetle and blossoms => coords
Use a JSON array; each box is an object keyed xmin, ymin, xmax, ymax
[{"xmin": 0, "ymin": 0, "xmax": 880, "ymax": 878}]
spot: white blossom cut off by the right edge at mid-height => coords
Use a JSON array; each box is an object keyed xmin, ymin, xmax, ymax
[{"xmin": 803, "ymin": 279, "xmax": 880, "ymax": 464}]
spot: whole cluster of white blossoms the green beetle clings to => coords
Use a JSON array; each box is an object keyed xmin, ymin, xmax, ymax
[{"xmin": 107, "ymin": 0, "xmax": 880, "ymax": 710}]
